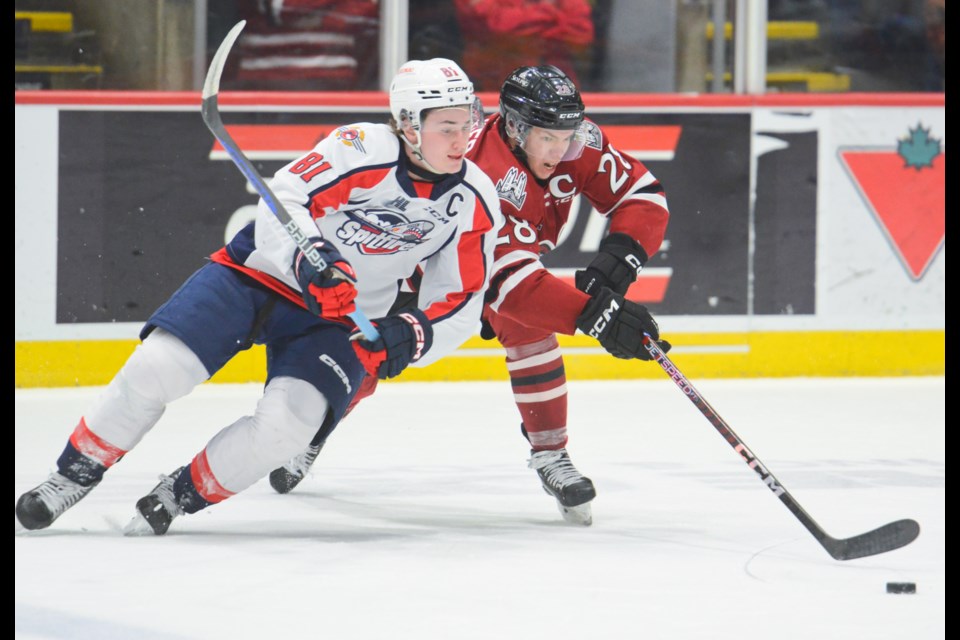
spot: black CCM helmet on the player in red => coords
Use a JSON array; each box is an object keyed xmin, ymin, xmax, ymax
[{"xmin": 500, "ymin": 65, "xmax": 584, "ymax": 129}]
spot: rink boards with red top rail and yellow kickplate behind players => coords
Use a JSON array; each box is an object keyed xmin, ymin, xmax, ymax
[{"xmin": 15, "ymin": 92, "xmax": 946, "ymax": 386}]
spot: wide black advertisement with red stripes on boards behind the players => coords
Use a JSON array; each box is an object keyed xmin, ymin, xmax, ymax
[{"xmin": 50, "ymin": 110, "xmax": 756, "ymax": 323}]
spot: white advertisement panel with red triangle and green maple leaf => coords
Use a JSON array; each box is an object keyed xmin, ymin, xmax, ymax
[{"xmin": 817, "ymin": 108, "xmax": 946, "ymax": 328}]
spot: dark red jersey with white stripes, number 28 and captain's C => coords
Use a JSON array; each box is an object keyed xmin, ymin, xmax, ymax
[{"xmin": 467, "ymin": 115, "xmax": 670, "ymax": 335}]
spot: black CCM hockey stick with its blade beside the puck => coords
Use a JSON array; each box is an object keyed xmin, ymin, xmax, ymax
[{"xmin": 643, "ymin": 334, "xmax": 920, "ymax": 560}]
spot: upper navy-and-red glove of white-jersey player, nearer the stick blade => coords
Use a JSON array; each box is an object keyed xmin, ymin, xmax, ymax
[{"xmin": 293, "ymin": 237, "xmax": 357, "ymax": 320}]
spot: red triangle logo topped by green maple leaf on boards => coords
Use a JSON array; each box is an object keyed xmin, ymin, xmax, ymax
[{"xmin": 838, "ymin": 123, "xmax": 947, "ymax": 280}]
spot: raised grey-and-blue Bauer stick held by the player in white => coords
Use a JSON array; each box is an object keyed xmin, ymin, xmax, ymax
[{"xmin": 200, "ymin": 20, "xmax": 380, "ymax": 342}]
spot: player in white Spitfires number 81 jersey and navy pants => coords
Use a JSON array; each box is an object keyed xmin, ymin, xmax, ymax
[{"xmin": 16, "ymin": 58, "xmax": 501, "ymax": 535}]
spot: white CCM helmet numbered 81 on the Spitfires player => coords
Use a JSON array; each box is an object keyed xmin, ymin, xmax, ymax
[{"xmin": 390, "ymin": 58, "xmax": 483, "ymax": 133}]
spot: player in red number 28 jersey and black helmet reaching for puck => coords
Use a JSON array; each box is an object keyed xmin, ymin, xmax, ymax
[{"xmin": 270, "ymin": 66, "xmax": 670, "ymax": 525}]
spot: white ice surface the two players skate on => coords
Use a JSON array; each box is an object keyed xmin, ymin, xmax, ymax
[{"xmin": 14, "ymin": 377, "xmax": 945, "ymax": 640}]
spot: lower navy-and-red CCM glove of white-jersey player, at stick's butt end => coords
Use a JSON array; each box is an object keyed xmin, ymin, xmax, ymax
[{"xmin": 350, "ymin": 309, "xmax": 433, "ymax": 380}]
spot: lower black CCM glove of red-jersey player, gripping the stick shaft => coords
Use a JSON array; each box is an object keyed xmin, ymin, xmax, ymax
[{"xmin": 577, "ymin": 288, "xmax": 670, "ymax": 360}]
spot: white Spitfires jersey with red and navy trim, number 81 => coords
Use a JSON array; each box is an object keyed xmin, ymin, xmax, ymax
[{"xmin": 211, "ymin": 123, "xmax": 502, "ymax": 366}]
